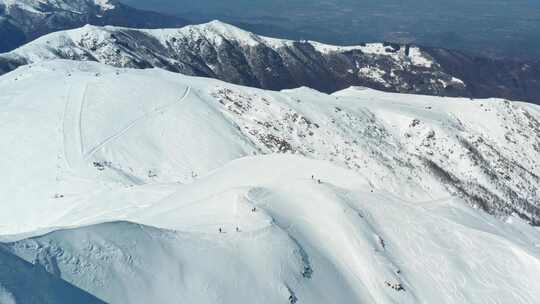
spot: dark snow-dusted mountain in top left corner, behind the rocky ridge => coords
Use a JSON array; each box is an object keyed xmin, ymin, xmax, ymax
[{"xmin": 0, "ymin": 0, "xmax": 187, "ymax": 52}]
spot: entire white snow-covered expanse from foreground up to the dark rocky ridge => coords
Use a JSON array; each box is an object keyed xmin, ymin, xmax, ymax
[{"xmin": 0, "ymin": 61, "xmax": 540, "ymax": 304}]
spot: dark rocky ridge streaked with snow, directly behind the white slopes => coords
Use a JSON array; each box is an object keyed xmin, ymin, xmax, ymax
[{"xmin": 0, "ymin": 21, "xmax": 540, "ymax": 102}]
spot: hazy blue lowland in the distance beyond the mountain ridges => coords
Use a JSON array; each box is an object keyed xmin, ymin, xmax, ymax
[{"xmin": 123, "ymin": 0, "xmax": 540, "ymax": 60}]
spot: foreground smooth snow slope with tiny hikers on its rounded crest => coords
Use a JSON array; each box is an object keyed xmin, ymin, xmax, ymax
[{"xmin": 6, "ymin": 155, "xmax": 540, "ymax": 303}]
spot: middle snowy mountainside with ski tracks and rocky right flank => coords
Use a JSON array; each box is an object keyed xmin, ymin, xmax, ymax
[{"xmin": 0, "ymin": 61, "xmax": 540, "ymax": 229}]
